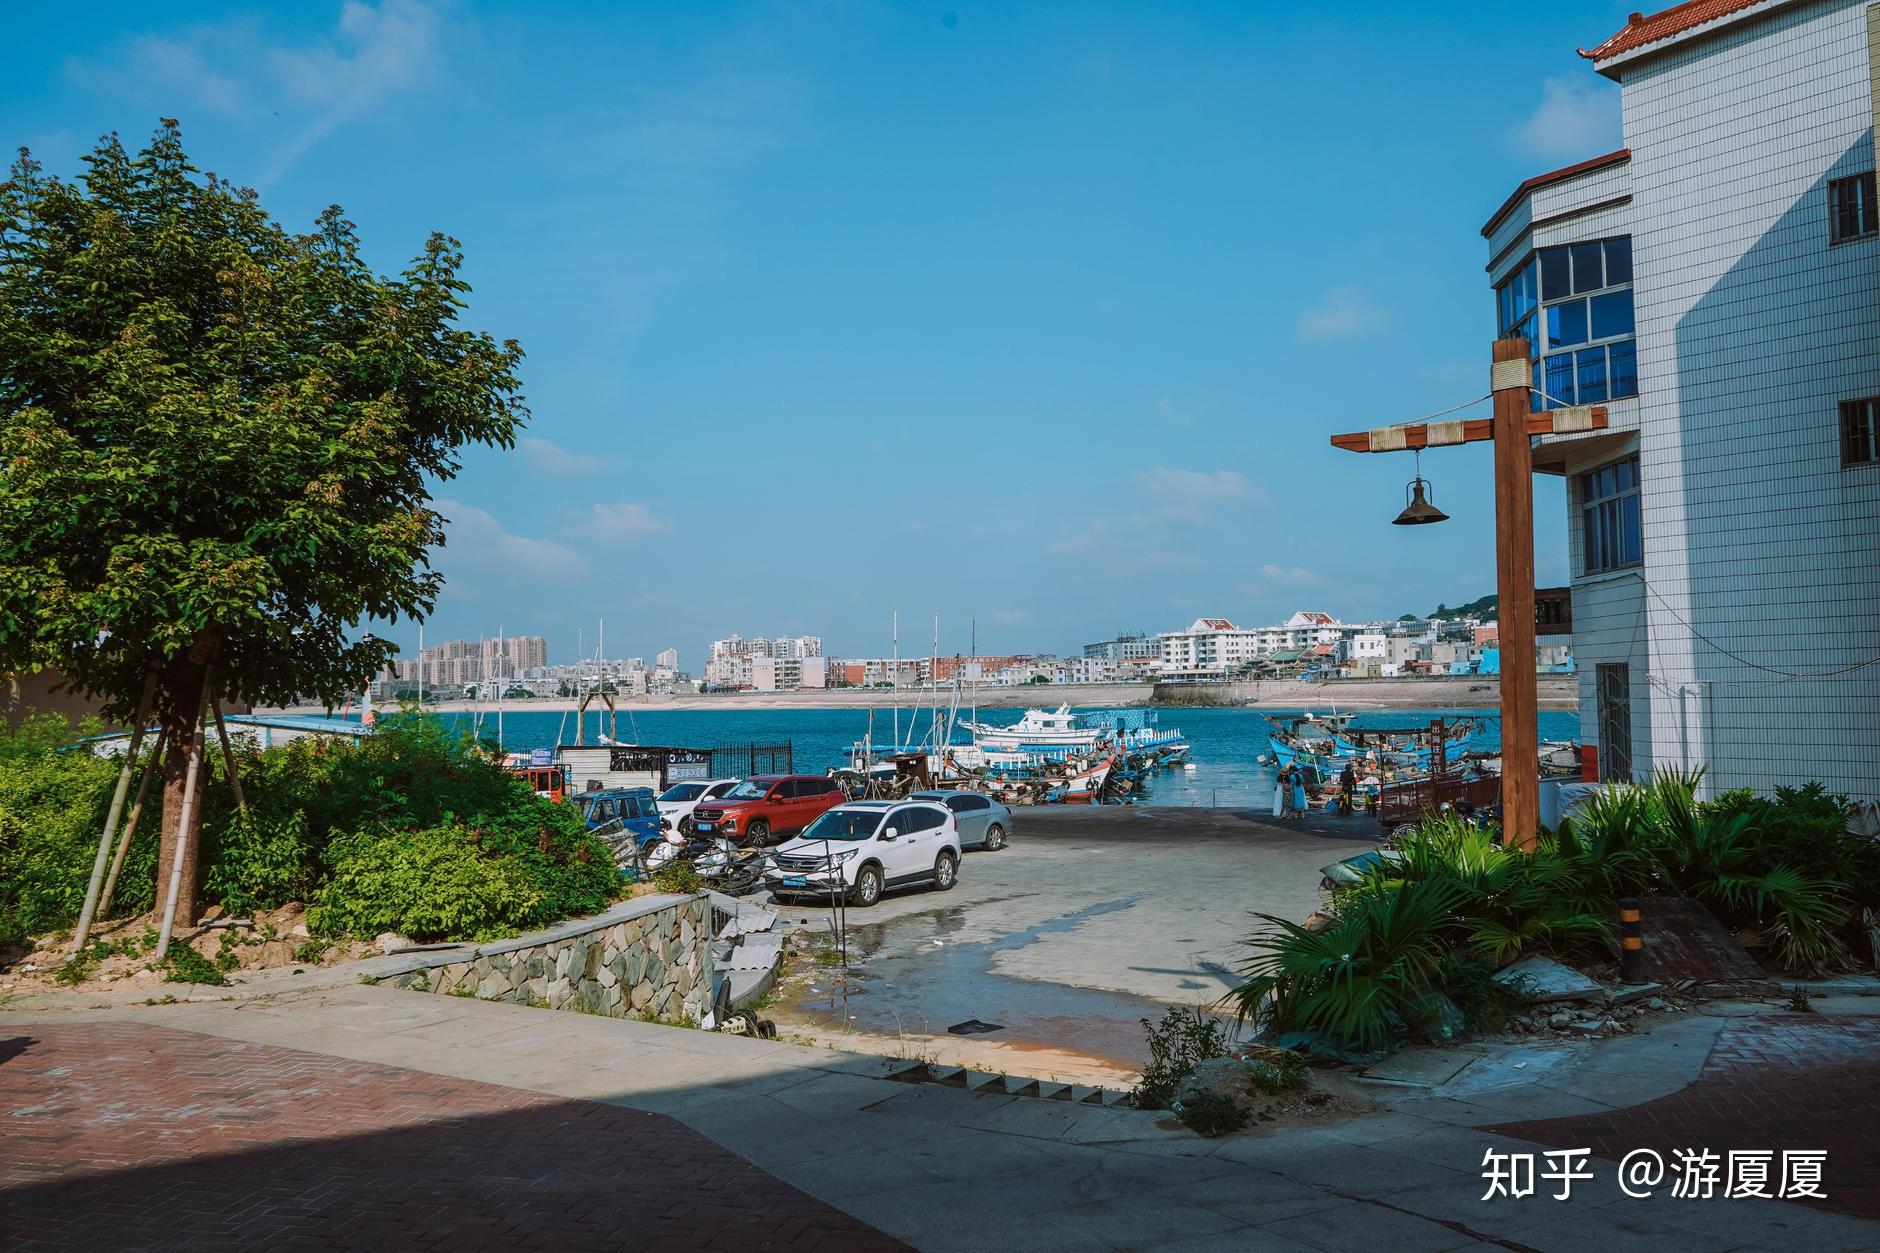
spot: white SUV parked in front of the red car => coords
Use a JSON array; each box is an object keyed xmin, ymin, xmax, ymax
[{"xmin": 763, "ymin": 801, "xmax": 959, "ymax": 905}]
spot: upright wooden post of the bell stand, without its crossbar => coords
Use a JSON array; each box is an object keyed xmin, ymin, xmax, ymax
[{"xmin": 1489, "ymin": 339, "xmax": 1540, "ymax": 849}]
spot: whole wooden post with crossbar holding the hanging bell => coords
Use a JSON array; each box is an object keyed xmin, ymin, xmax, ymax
[{"xmin": 1331, "ymin": 339, "xmax": 1607, "ymax": 849}]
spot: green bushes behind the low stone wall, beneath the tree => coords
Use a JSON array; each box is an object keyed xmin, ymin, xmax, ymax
[{"xmin": 0, "ymin": 703, "xmax": 619, "ymax": 943}]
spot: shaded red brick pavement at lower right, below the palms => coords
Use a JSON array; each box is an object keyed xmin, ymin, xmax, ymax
[{"xmin": 1483, "ymin": 1014, "xmax": 1880, "ymax": 1219}]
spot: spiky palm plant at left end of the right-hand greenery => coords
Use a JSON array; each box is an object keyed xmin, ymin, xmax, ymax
[{"xmin": 1228, "ymin": 879, "xmax": 1461, "ymax": 1052}]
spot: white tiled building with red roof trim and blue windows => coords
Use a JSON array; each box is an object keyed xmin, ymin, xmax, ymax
[{"xmin": 1483, "ymin": 0, "xmax": 1880, "ymax": 796}]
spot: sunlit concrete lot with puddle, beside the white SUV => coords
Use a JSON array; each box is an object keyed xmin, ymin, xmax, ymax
[{"xmin": 767, "ymin": 805, "xmax": 1376, "ymax": 1082}]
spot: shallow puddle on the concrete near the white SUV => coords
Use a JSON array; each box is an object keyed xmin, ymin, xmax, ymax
[{"xmin": 786, "ymin": 894, "xmax": 1167, "ymax": 1071}]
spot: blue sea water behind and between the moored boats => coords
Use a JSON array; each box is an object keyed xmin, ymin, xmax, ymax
[{"xmin": 404, "ymin": 707, "xmax": 1579, "ymax": 807}]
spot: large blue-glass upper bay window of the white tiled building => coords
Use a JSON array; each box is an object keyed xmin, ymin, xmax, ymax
[{"xmin": 1495, "ymin": 237, "xmax": 1639, "ymax": 408}]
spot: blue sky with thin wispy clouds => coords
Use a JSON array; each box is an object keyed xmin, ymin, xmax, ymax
[{"xmin": 0, "ymin": 0, "xmax": 1632, "ymax": 668}]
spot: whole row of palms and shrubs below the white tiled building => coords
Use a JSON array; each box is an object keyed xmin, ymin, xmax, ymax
[{"xmin": 1230, "ymin": 773, "xmax": 1880, "ymax": 1055}]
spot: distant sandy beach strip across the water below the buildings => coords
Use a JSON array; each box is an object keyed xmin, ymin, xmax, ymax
[{"xmin": 288, "ymin": 675, "xmax": 1579, "ymax": 713}]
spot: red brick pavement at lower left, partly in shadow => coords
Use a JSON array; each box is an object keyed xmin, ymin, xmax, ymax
[{"xmin": 0, "ymin": 1023, "xmax": 906, "ymax": 1253}]
